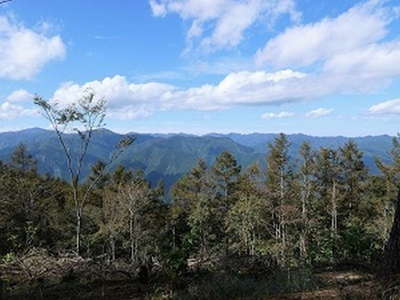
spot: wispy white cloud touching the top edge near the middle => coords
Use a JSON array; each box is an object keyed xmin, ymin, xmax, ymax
[{"xmin": 149, "ymin": 0, "xmax": 300, "ymax": 52}]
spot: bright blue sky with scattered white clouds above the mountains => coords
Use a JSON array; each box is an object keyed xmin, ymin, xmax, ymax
[{"xmin": 0, "ymin": 0, "xmax": 400, "ymax": 136}]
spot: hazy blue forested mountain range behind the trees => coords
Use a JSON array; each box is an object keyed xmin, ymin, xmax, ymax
[{"xmin": 0, "ymin": 128, "xmax": 393, "ymax": 190}]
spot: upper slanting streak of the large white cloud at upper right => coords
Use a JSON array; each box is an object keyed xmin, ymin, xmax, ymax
[{"xmin": 255, "ymin": 1, "xmax": 391, "ymax": 67}]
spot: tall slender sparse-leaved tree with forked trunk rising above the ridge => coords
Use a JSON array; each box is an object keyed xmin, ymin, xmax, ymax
[{"xmin": 34, "ymin": 92, "xmax": 133, "ymax": 255}]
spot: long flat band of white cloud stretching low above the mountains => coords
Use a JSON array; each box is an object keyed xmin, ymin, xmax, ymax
[{"xmin": 52, "ymin": 65, "xmax": 400, "ymax": 119}]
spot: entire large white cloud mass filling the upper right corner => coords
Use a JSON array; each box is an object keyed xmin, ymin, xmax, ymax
[{"xmin": 255, "ymin": 0, "xmax": 400, "ymax": 101}]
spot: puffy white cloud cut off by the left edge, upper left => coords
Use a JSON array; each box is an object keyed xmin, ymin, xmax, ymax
[{"xmin": 0, "ymin": 16, "xmax": 66, "ymax": 79}]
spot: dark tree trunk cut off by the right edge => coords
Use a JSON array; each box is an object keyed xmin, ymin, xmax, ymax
[{"xmin": 384, "ymin": 186, "xmax": 400, "ymax": 274}]
